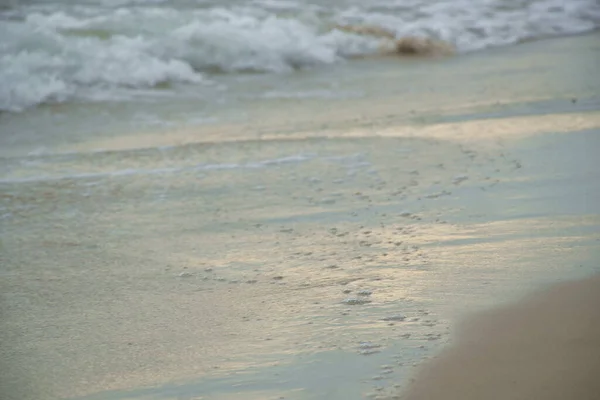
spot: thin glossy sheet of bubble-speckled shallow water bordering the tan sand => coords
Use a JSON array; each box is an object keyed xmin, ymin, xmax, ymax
[{"xmin": 1, "ymin": 114, "xmax": 600, "ymax": 399}]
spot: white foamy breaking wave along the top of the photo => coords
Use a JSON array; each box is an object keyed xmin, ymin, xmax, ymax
[{"xmin": 0, "ymin": 0, "xmax": 600, "ymax": 111}]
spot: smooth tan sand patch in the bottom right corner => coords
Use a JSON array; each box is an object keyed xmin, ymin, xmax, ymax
[{"xmin": 402, "ymin": 275, "xmax": 600, "ymax": 400}]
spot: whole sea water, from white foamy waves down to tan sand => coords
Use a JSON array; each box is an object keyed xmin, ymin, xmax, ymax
[{"xmin": 0, "ymin": 0, "xmax": 600, "ymax": 399}]
